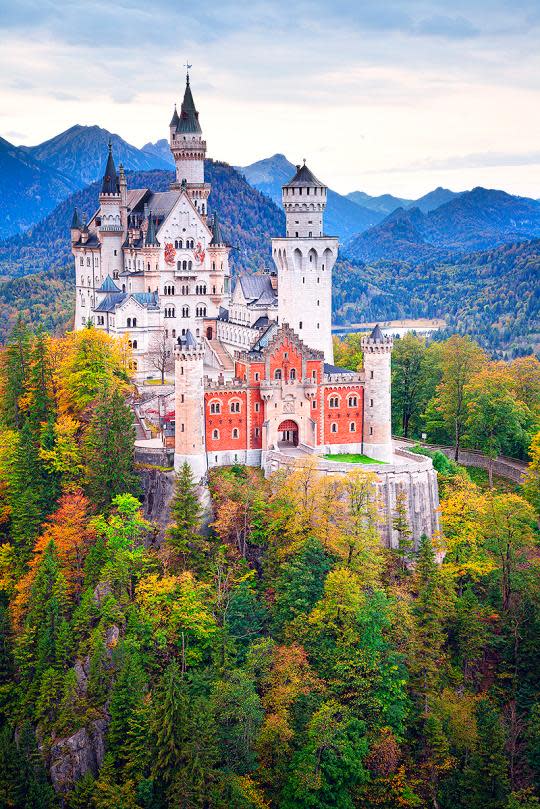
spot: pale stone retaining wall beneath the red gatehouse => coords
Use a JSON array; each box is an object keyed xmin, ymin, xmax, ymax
[{"xmin": 263, "ymin": 449, "xmax": 440, "ymax": 547}]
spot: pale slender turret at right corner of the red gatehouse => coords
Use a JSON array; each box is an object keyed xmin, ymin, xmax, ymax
[{"xmin": 362, "ymin": 325, "xmax": 393, "ymax": 462}]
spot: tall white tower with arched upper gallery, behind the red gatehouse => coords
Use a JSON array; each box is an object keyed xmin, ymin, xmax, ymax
[{"xmin": 272, "ymin": 162, "xmax": 338, "ymax": 364}]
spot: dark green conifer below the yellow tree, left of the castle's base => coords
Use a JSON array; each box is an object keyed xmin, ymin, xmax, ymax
[{"xmin": 84, "ymin": 389, "xmax": 140, "ymax": 511}]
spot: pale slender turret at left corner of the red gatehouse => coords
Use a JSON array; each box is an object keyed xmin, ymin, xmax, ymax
[{"xmin": 174, "ymin": 329, "xmax": 208, "ymax": 482}]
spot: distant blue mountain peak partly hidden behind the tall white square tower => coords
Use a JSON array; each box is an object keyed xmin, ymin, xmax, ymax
[{"xmin": 237, "ymin": 154, "xmax": 384, "ymax": 241}]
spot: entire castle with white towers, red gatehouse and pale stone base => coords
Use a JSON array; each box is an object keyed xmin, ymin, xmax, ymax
[{"xmin": 71, "ymin": 76, "xmax": 438, "ymax": 542}]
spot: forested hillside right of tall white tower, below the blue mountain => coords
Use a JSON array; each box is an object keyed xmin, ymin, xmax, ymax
[{"xmin": 334, "ymin": 239, "xmax": 540, "ymax": 354}]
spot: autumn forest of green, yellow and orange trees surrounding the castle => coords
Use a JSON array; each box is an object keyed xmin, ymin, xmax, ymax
[{"xmin": 0, "ymin": 322, "xmax": 540, "ymax": 809}]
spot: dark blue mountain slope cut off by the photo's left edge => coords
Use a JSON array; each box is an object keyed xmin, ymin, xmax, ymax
[{"xmin": 0, "ymin": 138, "xmax": 76, "ymax": 238}]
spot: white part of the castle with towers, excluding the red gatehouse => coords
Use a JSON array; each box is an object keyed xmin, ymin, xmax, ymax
[{"xmin": 71, "ymin": 70, "xmax": 338, "ymax": 372}]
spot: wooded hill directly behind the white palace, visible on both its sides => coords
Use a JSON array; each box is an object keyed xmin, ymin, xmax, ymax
[{"xmin": 0, "ymin": 160, "xmax": 285, "ymax": 341}]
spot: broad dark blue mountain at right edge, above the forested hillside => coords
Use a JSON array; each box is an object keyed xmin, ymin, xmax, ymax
[{"xmin": 346, "ymin": 188, "xmax": 540, "ymax": 262}]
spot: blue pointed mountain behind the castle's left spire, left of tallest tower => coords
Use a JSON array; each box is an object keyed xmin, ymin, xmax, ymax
[{"xmin": 23, "ymin": 124, "xmax": 170, "ymax": 188}]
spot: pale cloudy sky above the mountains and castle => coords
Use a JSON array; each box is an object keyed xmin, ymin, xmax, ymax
[{"xmin": 0, "ymin": 0, "xmax": 540, "ymax": 198}]
